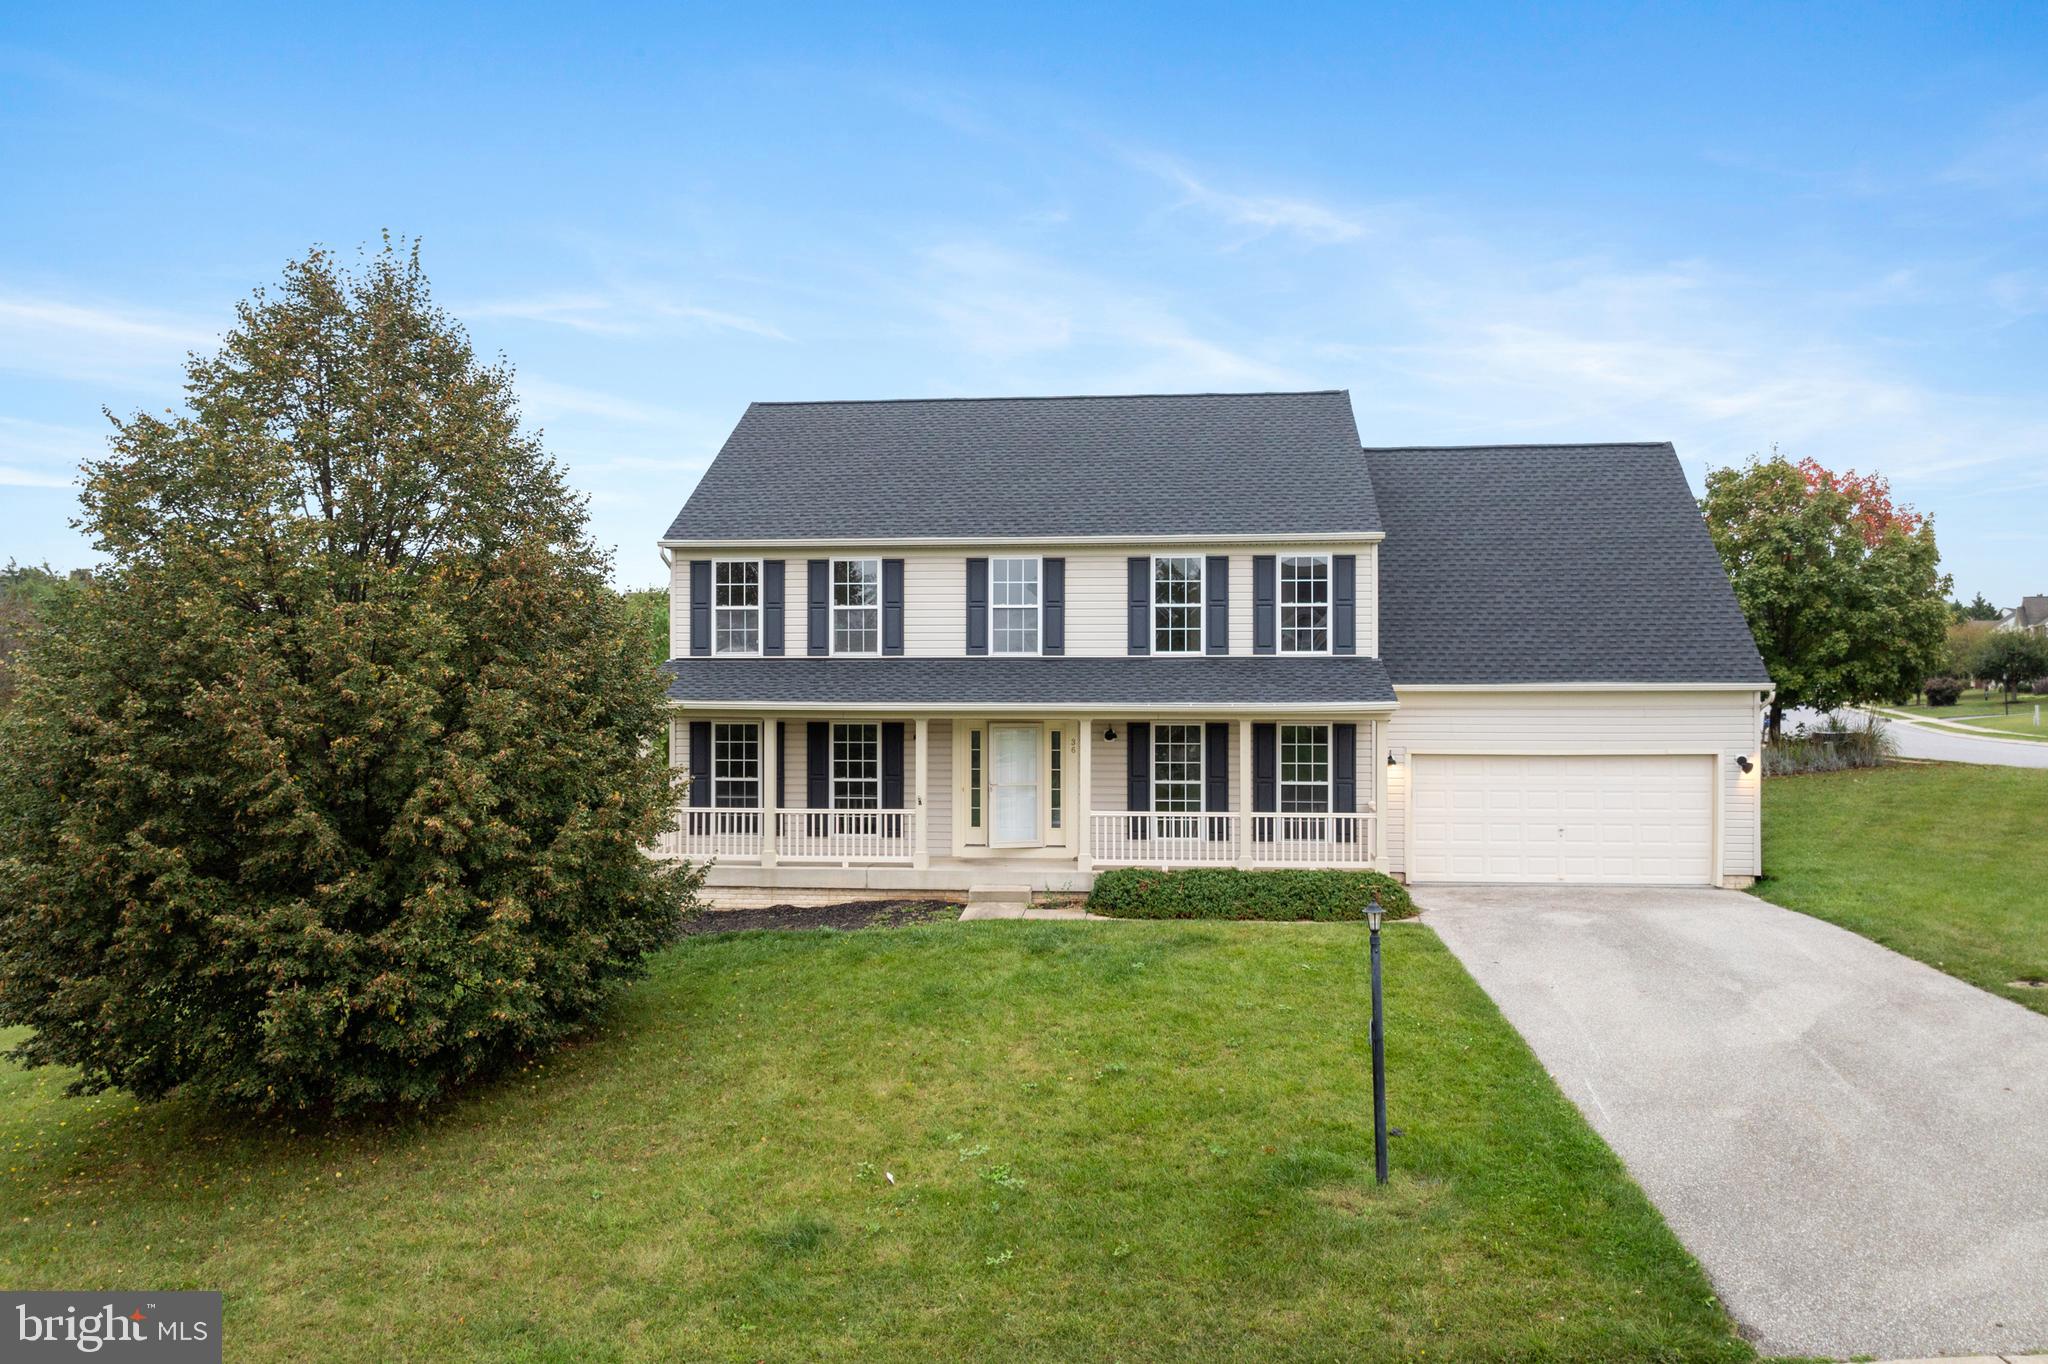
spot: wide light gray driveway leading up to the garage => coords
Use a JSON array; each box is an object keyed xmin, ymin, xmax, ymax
[{"xmin": 1417, "ymin": 887, "xmax": 2048, "ymax": 1358}]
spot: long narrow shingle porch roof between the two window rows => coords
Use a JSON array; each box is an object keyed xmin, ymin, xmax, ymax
[{"xmin": 662, "ymin": 657, "xmax": 1395, "ymax": 709}]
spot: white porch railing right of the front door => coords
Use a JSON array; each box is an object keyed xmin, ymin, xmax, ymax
[{"xmin": 1087, "ymin": 811, "xmax": 1378, "ymax": 866}]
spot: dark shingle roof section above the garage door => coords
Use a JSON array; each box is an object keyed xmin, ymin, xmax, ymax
[{"xmin": 1366, "ymin": 444, "xmax": 1769, "ymax": 686}]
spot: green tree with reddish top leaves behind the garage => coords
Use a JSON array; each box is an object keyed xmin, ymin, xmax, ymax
[{"xmin": 1702, "ymin": 453, "xmax": 1950, "ymax": 739}]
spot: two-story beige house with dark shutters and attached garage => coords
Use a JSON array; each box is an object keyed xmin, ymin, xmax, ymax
[{"xmin": 662, "ymin": 391, "xmax": 1769, "ymax": 891}]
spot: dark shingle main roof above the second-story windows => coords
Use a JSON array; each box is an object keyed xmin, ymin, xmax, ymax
[{"xmin": 666, "ymin": 389, "xmax": 1380, "ymax": 541}]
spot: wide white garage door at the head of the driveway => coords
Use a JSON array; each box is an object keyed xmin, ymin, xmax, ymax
[{"xmin": 1409, "ymin": 754, "xmax": 1714, "ymax": 885}]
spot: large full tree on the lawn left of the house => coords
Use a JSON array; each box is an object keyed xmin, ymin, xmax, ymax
[{"xmin": 0, "ymin": 242, "xmax": 696, "ymax": 1110}]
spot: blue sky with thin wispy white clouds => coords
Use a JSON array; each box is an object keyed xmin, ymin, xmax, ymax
[{"xmin": 0, "ymin": 4, "xmax": 2048, "ymax": 602}]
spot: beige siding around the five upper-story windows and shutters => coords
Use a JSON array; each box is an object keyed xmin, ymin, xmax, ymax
[{"xmin": 670, "ymin": 541, "xmax": 1380, "ymax": 657}]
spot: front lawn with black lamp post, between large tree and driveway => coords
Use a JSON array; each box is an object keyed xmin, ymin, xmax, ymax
[{"xmin": 0, "ymin": 913, "xmax": 1761, "ymax": 1362}]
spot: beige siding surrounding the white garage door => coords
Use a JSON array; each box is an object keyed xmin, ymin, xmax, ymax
[{"xmin": 1362, "ymin": 690, "xmax": 1763, "ymax": 877}]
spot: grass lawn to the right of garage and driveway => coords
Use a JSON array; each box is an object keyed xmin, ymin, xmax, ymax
[{"xmin": 1755, "ymin": 764, "xmax": 2048, "ymax": 1014}]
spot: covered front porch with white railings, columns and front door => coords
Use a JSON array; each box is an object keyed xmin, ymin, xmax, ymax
[{"xmin": 653, "ymin": 713, "xmax": 1386, "ymax": 893}]
